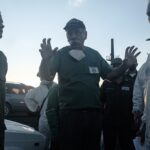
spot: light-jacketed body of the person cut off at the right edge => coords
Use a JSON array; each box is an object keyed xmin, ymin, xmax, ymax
[{"xmin": 133, "ymin": 54, "xmax": 150, "ymax": 150}]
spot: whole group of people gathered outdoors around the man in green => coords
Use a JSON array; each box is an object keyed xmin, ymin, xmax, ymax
[{"xmin": 0, "ymin": 0, "xmax": 150, "ymax": 150}]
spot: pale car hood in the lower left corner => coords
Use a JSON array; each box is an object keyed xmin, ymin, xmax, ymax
[{"xmin": 5, "ymin": 120, "xmax": 45, "ymax": 150}]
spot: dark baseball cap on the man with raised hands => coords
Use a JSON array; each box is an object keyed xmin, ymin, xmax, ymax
[{"xmin": 64, "ymin": 18, "xmax": 86, "ymax": 31}]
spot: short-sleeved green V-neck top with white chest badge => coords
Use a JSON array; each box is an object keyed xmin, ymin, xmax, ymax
[{"xmin": 42, "ymin": 46, "xmax": 111, "ymax": 109}]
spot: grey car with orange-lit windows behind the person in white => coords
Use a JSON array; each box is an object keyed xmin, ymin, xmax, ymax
[{"xmin": 4, "ymin": 82, "xmax": 34, "ymax": 116}]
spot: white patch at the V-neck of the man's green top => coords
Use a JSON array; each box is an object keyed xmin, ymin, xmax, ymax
[{"xmin": 69, "ymin": 49, "xmax": 85, "ymax": 61}]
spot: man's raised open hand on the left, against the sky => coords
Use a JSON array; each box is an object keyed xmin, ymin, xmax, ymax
[{"xmin": 39, "ymin": 38, "xmax": 58, "ymax": 59}]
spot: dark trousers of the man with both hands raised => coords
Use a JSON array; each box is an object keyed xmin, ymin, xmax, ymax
[{"xmin": 59, "ymin": 110, "xmax": 102, "ymax": 150}]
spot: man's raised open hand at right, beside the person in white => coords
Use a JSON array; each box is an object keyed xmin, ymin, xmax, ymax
[{"xmin": 125, "ymin": 46, "xmax": 141, "ymax": 67}]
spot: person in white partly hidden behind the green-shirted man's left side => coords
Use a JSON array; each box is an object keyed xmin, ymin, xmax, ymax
[{"xmin": 24, "ymin": 74, "xmax": 56, "ymax": 150}]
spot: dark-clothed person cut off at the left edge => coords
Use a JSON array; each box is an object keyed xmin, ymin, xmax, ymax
[{"xmin": 0, "ymin": 13, "xmax": 7, "ymax": 150}]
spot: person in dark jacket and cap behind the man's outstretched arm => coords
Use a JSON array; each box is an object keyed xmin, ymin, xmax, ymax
[{"xmin": 101, "ymin": 58, "xmax": 137, "ymax": 150}]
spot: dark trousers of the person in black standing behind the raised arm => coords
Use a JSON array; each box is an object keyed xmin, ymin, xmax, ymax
[{"xmin": 103, "ymin": 124, "xmax": 135, "ymax": 150}]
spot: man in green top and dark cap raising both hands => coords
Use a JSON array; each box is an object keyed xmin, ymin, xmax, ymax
[{"xmin": 39, "ymin": 18, "xmax": 139, "ymax": 150}]
